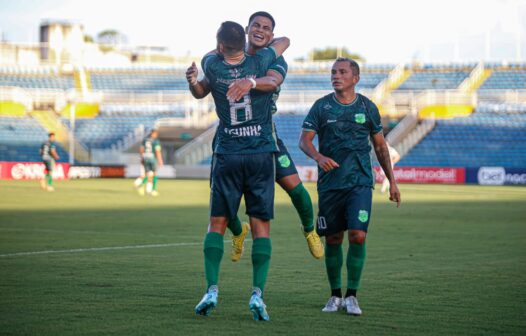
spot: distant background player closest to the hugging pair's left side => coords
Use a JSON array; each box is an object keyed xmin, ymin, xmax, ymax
[{"xmin": 139, "ymin": 129, "xmax": 163, "ymax": 196}]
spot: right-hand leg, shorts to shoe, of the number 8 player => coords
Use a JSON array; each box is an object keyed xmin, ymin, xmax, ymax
[{"xmin": 244, "ymin": 153, "xmax": 275, "ymax": 321}]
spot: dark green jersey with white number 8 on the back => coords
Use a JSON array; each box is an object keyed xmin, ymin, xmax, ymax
[{"xmin": 201, "ymin": 48, "xmax": 277, "ymax": 154}]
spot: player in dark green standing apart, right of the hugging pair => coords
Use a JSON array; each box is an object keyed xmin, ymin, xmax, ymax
[{"xmin": 300, "ymin": 58, "xmax": 401, "ymax": 315}]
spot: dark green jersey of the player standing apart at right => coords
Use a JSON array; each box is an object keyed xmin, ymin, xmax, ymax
[{"xmin": 303, "ymin": 93, "xmax": 382, "ymax": 191}]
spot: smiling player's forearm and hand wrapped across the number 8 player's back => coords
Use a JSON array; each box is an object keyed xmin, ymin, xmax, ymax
[{"xmin": 226, "ymin": 70, "xmax": 283, "ymax": 101}]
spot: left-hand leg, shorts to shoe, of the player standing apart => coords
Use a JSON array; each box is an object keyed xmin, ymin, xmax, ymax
[{"xmin": 317, "ymin": 190, "xmax": 348, "ymax": 313}]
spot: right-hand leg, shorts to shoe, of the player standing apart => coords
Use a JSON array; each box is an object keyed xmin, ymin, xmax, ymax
[{"xmin": 345, "ymin": 186, "xmax": 372, "ymax": 315}]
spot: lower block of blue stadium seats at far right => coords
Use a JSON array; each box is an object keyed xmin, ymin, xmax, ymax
[{"xmin": 398, "ymin": 104, "xmax": 526, "ymax": 168}]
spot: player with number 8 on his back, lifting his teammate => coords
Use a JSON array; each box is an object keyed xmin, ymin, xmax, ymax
[{"xmin": 187, "ymin": 21, "xmax": 289, "ymax": 321}]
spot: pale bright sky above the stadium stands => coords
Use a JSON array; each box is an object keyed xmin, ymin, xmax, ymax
[{"xmin": 0, "ymin": 0, "xmax": 526, "ymax": 63}]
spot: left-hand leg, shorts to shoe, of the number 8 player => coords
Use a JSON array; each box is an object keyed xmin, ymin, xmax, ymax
[{"xmin": 195, "ymin": 154, "xmax": 242, "ymax": 315}]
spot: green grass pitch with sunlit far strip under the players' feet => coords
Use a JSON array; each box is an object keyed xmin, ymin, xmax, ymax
[{"xmin": 0, "ymin": 180, "xmax": 526, "ymax": 336}]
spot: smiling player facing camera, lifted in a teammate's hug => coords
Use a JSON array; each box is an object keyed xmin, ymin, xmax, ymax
[{"xmin": 220, "ymin": 12, "xmax": 323, "ymax": 261}]
